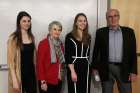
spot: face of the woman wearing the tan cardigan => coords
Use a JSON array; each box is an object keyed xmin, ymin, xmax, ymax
[{"xmin": 20, "ymin": 16, "xmax": 31, "ymax": 31}]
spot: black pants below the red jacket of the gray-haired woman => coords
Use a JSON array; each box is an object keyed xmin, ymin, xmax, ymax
[{"xmin": 39, "ymin": 81, "xmax": 62, "ymax": 93}]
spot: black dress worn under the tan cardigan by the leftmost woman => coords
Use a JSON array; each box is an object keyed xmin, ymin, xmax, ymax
[{"xmin": 21, "ymin": 43, "xmax": 37, "ymax": 93}]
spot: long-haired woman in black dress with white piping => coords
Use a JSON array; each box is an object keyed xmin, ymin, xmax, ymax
[{"xmin": 65, "ymin": 13, "xmax": 91, "ymax": 93}]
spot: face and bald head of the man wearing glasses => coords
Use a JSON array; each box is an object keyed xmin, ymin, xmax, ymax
[{"xmin": 106, "ymin": 10, "xmax": 120, "ymax": 28}]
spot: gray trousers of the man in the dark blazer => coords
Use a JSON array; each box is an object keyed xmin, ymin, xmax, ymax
[{"xmin": 102, "ymin": 64, "xmax": 132, "ymax": 93}]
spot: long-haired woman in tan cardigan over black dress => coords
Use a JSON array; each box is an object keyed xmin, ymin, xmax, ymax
[{"xmin": 7, "ymin": 11, "xmax": 37, "ymax": 93}]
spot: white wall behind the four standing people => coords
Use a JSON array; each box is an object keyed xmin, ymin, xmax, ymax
[{"xmin": 0, "ymin": 0, "xmax": 107, "ymax": 93}]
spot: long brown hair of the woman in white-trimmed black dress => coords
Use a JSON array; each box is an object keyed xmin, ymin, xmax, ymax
[{"xmin": 72, "ymin": 13, "xmax": 91, "ymax": 45}]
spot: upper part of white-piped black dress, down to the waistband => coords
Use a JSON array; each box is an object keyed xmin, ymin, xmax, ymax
[{"xmin": 65, "ymin": 33, "xmax": 90, "ymax": 64}]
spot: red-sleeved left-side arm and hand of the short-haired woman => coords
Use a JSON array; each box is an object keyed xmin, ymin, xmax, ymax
[{"xmin": 36, "ymin": 42, "xmax": 47, "ymax": 91}]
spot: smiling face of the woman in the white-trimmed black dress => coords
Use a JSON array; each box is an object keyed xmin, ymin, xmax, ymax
[{"xmin": 76, "ymin": 16, "xmax": 87, "ymax": 31}]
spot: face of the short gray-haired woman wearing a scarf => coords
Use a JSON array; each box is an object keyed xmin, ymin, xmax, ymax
[{"xmin": 50, "ymin": 25, "xmax": 62, "ymax": 39}]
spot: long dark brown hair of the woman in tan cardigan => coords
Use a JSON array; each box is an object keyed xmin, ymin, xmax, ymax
[{"xmin": 12, "ymin": 11, "xmax": 34, "ymax": 49}]
